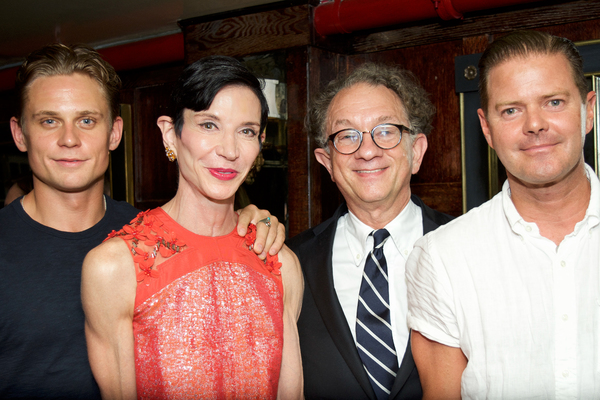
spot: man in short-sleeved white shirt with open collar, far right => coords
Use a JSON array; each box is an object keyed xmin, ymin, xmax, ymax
[{"xmin": 407, "ymin": 31, "xmax": 600, "ymax": 399}]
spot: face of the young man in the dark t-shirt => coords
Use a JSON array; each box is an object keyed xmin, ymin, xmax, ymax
[{"xmin": 11, "ymin": 73, "xmax": 122, "ymax": 193}]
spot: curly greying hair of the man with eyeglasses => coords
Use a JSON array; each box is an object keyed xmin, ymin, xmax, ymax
[{"xmin": 306, "ymin": 63, "xmax": 435, "ymax": 149}]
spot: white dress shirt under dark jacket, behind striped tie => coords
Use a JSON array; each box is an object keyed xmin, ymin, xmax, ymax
[{"xmin": 333, "ymin": 201, "xmax": 423, "ymax": 365}]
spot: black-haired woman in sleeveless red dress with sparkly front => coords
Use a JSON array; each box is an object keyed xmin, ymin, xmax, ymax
[{"xmin": 82, "ymin": 56, "xmax": 303, "ymax": 399}]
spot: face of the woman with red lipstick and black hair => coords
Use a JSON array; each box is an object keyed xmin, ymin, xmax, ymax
[{"xmin": 158, "ymin": 86, "xmax": 264, "ymax": 201}]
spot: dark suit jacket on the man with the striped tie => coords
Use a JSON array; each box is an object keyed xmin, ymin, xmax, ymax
[{"xmin": 287, "ymin": 195, "xmax": 452, "ymax": 399}]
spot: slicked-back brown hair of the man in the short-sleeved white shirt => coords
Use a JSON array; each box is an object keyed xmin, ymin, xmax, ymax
[{"xmin": 479, "ymin": 31, "xmax": 588, "ymax": 113}]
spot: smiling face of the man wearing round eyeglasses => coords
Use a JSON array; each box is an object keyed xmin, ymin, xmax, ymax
[{"xmin": 315, "ymin": 83, "xmax": 427, "ymax": 215}]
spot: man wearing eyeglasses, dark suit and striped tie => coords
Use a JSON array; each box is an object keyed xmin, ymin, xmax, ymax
[{"xmin": 289, "ymin": 64, "xmax": 451, "ymax": 399}]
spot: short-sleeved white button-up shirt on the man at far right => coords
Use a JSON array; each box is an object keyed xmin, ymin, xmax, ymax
[{"xmin": 406, "ymin": 167, "xmax": 600, "ymax": 399}]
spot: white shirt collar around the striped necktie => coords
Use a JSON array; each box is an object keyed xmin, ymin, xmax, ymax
[{"xmin": 342, "ymin": 200, "xmax": 423, "ymax": 265}]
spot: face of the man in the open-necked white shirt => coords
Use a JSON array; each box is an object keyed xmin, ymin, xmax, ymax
[{"xmin": 478, "ymin": 54, "xmax": 595, "ymax": 186}]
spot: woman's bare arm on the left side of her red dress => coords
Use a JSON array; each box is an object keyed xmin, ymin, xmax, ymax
[{"xmin": 81, "ymin": 238, "xmax": 137, "ymax": 399}]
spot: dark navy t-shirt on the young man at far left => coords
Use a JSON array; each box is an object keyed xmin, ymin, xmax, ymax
[{"xmin": 0, "ymin": 197, "xmax": 139, "ymax": 399}]
